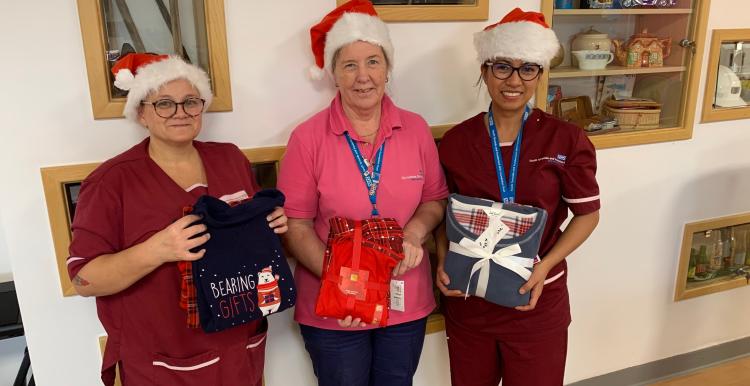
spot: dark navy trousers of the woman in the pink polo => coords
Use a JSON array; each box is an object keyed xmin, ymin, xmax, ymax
[{"xmin": 300, "ymin": 318, "xmax": 427, "ymax": 386}]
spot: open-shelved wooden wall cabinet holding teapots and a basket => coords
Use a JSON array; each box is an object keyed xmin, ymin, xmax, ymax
[{"xmin": 536, "ymin": 0, "xmax": 710, "ymax": 148}]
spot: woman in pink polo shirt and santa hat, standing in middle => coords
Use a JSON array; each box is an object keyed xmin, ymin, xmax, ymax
[{"xmin": 278, "ymin": 0, "xmax": 448, "ymax": 386}]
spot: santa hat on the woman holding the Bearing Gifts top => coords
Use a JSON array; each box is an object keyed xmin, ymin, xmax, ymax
[{"xmin": 112, "ymin": 53, "xmax": 213, "ymax": 121}]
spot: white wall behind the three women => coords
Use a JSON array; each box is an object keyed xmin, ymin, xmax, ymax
[{"xmin": 0, "ymin": 0, "xmax": 750, "ymax": 386}]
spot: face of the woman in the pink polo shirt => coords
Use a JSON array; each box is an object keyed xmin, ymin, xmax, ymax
[{"xmin": 333, "ymin": 41, "xmax": 388, "ymax": 114}]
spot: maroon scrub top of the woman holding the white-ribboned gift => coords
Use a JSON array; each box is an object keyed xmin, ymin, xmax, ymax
[{"xmin": 438, "ymin": 109, "xmax": 600, "ymax": 336}]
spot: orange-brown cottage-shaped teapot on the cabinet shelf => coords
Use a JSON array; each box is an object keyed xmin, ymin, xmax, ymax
[{"xmin": 612, "ymin": 28, "xmax": 672, "ymax": 67}]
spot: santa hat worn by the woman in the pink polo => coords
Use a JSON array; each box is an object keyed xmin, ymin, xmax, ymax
[{"xmin": 310, "ymin": 0, "xmax": 393, "ymax": 80}]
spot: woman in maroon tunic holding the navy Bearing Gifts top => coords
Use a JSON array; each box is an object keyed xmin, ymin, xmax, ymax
[{"xmin": 67, "ymin": 54, "xmax": 287, "ymax": 386}]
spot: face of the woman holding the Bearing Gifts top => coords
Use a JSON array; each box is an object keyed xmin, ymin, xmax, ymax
[{"xmin": 138, "ymin": 79, "xmax": 203, "ymax": 145}]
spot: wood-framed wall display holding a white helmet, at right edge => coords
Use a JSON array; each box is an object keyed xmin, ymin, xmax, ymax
[{"xmin": 701, "ymin": 28, "xmax": 750, "ymax": 123}]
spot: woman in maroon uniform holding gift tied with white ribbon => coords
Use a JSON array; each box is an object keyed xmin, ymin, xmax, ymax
[{"xmin": 436, "ymin": 8, "xmax": 600, "ymax": 386}]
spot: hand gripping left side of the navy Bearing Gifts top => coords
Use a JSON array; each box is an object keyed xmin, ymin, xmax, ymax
[{"xmin": 148, "ymin": 214, "xmax": 211, "ymax": 263}]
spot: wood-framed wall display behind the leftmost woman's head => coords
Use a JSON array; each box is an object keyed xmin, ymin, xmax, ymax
[{"xmin": 78, "ymin": 0, "xmax": 232, "ymax": 119}]
